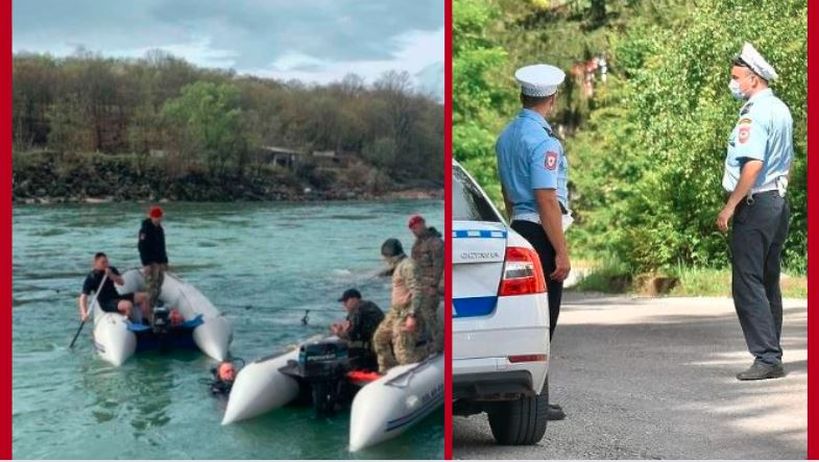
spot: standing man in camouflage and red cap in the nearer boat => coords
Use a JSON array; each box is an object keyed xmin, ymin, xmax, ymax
[{"xmin": 408, "ymin": 215, "xmax": 444, "ymax": 352}]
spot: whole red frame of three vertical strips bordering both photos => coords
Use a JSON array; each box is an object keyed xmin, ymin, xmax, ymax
[{"xmin": 0, "ymin": 0, "xmax": 819, "ymax": 459}]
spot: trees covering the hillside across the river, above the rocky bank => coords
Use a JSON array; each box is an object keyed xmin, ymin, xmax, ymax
[{"xmin": 12, "ymin": 51, "xmax": 444, "ymax": 188}]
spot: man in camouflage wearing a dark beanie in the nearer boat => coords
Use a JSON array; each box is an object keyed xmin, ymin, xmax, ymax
[{"xmin": 373, "ymin": 239, "xmax": 427, "ymax": 374}]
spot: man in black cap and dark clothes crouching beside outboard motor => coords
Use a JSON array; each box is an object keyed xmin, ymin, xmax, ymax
[{"xmin": 330, "ymin": 289, "xmax": 384, "ymax": 369}]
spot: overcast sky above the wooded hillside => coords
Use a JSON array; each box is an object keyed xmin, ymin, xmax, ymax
[{"xmin": 13, "ymin": 0, "xmax": 444, "ymax": 98}]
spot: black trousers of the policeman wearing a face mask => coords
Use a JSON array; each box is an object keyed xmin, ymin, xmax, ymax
[{"xmin": 731, "ymin": 191, "xmax": 790, "ymax": 365}]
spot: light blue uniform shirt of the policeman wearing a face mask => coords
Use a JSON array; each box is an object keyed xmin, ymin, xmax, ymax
[{"xmin": 722, "ymin": 88, "xmax": 793, "ymax": 192}]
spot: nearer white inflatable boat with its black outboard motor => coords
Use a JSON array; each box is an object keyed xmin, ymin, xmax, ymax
[{"xmin": 222, "ymin": 337, "xmax": 444, "ymax": 451}]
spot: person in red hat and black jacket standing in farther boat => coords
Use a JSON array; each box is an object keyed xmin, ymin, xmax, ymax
[{"xmin": 137, "ymin": 206, "xmax": 168, "ymax": 321}]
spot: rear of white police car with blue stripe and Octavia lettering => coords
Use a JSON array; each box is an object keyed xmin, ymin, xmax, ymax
[{"xmin": 452, "ymin": 162, "xmax": 549, "ymax": 445}]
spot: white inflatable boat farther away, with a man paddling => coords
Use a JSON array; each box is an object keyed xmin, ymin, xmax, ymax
[{"xmin": 93, "ymin": 269, "xmax": 233, "ymax": 366}]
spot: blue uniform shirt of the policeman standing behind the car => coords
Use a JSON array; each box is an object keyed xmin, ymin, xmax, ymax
[{"xmin": 495, "ymin": 109, "xmax": 569, "ymax": 216}]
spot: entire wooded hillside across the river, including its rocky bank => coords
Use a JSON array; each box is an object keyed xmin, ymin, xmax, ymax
[{"xmin": 13, "ymin": 51, "xmax": 444, "ymax": 200}]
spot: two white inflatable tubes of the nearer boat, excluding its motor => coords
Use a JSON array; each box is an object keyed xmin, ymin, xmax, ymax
[{"xmin": 222, "ymin": 337, "xmax": 444, "ymax": 451}]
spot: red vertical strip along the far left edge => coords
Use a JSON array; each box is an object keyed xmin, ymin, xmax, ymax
[{"xmin": 0, "ymin": 0, "xmax": 12, "ymax": 459}]
